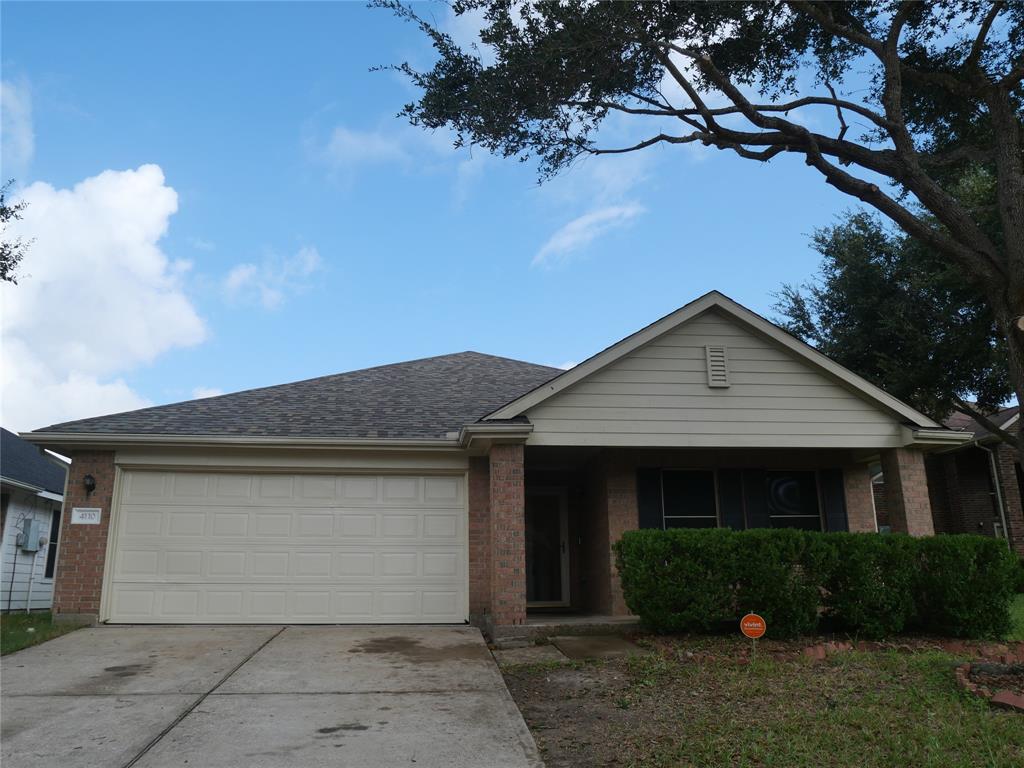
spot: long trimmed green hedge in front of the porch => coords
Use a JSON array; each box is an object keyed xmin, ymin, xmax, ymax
[{"xmin": 615, "ymin": 528, "xmax": 1020, "ymax": 638}]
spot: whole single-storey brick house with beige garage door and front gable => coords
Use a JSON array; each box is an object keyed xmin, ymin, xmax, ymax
[{"xmin": 19, "ymin": 292, "xmax": 971, "ymax": 636}]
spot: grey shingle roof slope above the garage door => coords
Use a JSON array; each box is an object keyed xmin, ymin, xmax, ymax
[{"xmin": 36, "ymin": 352, "xmax": 562, "ymax": 439}]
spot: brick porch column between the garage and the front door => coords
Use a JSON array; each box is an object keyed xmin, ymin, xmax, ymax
[{"xmin": 489, "ymin": 443, "xmax": 526, "ymax": 628}]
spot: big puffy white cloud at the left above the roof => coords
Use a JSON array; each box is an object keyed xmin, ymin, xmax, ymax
[{"xmin": 0, "ymin": 165, "xmax": 206, "ymax": 429}]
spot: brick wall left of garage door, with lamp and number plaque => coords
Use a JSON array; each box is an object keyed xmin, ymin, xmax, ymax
[{"xmin": 53, "ymin": 451, "xmax": 114, "ymax": 618}]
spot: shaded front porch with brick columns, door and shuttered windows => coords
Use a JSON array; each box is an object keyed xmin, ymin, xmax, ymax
[{"xmin": 469, "ymin": 443, "xmax": 933, "ymax": 638}]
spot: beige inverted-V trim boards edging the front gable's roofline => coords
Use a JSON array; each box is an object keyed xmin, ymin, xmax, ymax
[{"xmin": 484, "ymin": 291, "xmax": 944, "ymax": 430}]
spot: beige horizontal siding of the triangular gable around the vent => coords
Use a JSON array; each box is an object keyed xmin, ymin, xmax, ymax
[{"xmin": 526, "ymin": 309, "xmax": 902, "ymax": 447}]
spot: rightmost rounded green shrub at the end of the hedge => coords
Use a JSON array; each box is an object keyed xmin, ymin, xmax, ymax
[{"xmin": 914, "ymin": 536, "xmax": 1018, "ymax": 638}]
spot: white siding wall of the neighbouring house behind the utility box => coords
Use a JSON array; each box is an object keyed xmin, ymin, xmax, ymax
[{"xmin": 0, "ymin": 490, "xmax": 55, "ymax": 610}]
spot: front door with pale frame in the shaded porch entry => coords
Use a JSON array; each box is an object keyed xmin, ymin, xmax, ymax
[{"xmin": 526, "ymin": 490, "xmax": 569, "ymax": 607}]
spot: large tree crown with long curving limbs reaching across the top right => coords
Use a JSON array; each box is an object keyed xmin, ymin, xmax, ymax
[{"xmin": 378, "ymin": 0, "xmax": 1024, "ymax": 450}]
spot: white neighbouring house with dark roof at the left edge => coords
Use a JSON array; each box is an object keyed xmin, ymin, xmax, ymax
[{"xmin": 0, "ymin": 429, "xmax": 68, "ymax": 611}]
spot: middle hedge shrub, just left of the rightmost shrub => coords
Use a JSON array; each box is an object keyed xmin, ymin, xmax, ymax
[{"xmin": 824, "ymin": 534, "xmax": 916, "ymax": 638}]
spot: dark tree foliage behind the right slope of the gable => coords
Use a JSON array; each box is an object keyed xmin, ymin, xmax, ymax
[{"xmin": 776, "ymin": 213, "xmax": 1013, "ymax": 436}]
